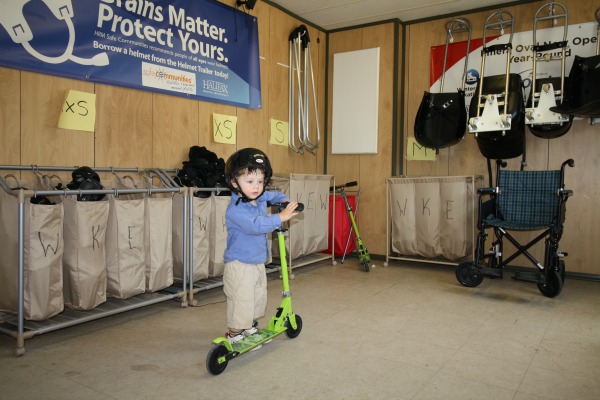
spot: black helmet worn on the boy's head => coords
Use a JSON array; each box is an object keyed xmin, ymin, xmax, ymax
[{"xmin": 225, "ymin": 147, "xmax": 273, "ymax": 201}]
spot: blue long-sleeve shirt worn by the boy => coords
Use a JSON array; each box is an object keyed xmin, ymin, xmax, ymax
[{"xmin": 224, "ymin": 192, "xmax": 290, "ymax": 264}]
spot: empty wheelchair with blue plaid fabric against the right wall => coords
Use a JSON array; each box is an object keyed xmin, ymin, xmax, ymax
[{"xmin": 456, "ymin": 159, "xmax": 575, "ymax": 297}]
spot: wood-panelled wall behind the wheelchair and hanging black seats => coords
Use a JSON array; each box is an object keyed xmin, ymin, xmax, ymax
[{"xmin": 402, "ymin": 0, "xmax": 600, "ymax": 275}]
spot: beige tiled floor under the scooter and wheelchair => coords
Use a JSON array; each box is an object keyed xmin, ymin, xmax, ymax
[{"xmin": 0, "ymin": 259, "xmax": 600, "ymax": 400}]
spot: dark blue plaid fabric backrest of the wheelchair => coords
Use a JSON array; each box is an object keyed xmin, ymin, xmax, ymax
[{"xmin": 485, "ymin": 171, "xmax": 561, "ymax": 230}]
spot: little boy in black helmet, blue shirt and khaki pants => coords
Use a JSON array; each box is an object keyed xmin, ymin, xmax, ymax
[{"xmin": 223, "ymin": 148, "xmax": 298, "ymax": 343}]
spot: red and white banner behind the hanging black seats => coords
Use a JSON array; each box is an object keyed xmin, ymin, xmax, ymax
[{"xmin": 430, "ymin": 22, "xmax": 598, "ymax": 108}]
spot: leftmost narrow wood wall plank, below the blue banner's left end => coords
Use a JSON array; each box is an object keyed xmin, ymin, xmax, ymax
[{"xmin": 0, "ymin": 67, "xmax": 21, "ymax": 165}]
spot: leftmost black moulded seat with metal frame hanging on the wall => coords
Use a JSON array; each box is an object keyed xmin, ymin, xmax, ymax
[{"xmin": 414, "ymin": 18, "xmax": 471, "ymax": 153}]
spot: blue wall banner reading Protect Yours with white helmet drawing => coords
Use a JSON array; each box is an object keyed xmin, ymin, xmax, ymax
[{"xmin": 0, "ymin": 0, "xmax": 262, "ymax": 108}]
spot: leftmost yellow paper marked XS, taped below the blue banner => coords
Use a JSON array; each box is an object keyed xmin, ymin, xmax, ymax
[{"xmin": 58, "ymin": 90, "xmax": 96, "ymax": 132}]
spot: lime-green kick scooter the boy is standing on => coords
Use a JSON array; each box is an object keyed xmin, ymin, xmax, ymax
[{"xmin": 206, "ymin": 202, "xmax": 304, "ymax": 375}]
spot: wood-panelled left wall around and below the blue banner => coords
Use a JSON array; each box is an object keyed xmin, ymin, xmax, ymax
[{"xmin": 0, "ymin": 0, "xmax": 326, "ymax": 178}]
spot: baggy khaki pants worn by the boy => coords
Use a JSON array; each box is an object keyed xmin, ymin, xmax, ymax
[{"xmin": 223, "ymin": 260, "xmax": 267, "ymax": 330}]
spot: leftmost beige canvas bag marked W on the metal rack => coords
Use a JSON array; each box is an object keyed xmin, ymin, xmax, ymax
[{"xmin": 0, "ymin": 177, "xmax": 64, "ymax": 321}]
